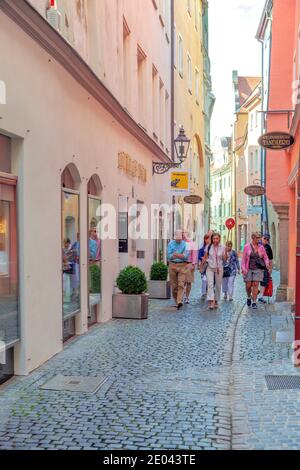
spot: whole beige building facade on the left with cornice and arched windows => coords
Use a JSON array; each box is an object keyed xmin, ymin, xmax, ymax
[{"xmin": 0, "ymin": 0, "xmax": 171, "ymax": 376}]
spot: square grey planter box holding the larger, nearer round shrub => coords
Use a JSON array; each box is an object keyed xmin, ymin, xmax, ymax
[{"xmin": 112, "ymin": 294, "xmax": 149, "ymax": 320}]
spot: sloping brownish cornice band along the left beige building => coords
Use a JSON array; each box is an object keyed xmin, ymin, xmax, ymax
[{"xmin": 0, "ymin": 0, "xmax": 171, "ymax": 162}]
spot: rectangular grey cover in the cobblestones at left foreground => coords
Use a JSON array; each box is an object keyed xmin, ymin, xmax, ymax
[{"xmin": 40, "ymin": 374, "xmax": 107, "ymax": 393}]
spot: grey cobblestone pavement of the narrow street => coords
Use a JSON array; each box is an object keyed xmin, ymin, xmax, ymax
[{"xmin": 0, "ymin": 279, "xmax": 300, "ymax": 450}]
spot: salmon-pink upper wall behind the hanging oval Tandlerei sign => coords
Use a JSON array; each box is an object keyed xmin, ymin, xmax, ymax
[{"xmin": 267, "ymin": 0, "xmax": 296, "ymax": 203}]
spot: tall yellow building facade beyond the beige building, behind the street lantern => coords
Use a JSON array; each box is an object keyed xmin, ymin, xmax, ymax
[{"xmin": 174, "ymin": 0, "xmax": 205, "ymax": 241}]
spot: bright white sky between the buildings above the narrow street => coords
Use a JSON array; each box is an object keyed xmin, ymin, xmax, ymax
[{"xmin": 209, "ymin": 0, "xmax": 265, "ymax": 144}]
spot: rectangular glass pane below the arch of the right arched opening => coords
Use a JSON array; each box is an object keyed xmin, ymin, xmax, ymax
[{"xmin": 88, "ymin": 196, "xmax": 102, "ymax": 326}]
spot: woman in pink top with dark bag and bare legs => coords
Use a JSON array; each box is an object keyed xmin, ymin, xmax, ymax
[{"xmin": 242, "ymin": 233, "xmax": 270, "ymax": 309}]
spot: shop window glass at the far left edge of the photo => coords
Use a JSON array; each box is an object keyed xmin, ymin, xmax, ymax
[{"xmin": 0, "ymin": 183, "xmax": 19, "ymax": 344}]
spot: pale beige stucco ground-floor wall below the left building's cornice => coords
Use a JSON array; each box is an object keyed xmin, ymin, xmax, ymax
[{"xmin": 0, "ymin": 7, "xmax": 169, "ymax": 373}]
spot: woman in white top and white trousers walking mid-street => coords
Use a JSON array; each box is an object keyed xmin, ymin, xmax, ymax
[{"xmin": 203, "ymin": 233, "xmax": 228, "ymax": 310}]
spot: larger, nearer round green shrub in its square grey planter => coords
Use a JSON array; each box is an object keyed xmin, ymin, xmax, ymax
[{"xmin": 112, "ymin": 266, "xmax": 149, "ymax": 320}]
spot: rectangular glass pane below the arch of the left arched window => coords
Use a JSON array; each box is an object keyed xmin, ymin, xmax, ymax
[{"xmin": 62, "ymin": 191, "xmax": 80, "ymax": 316}]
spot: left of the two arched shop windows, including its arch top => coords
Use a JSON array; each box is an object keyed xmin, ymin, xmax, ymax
[{"xmin": 62, "ymin": 164, "xmax": 80, "ymax": 339}]
